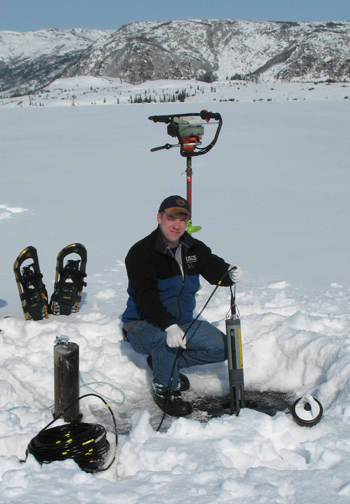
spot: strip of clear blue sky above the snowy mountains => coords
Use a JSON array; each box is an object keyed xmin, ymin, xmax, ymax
[{"xmin": 0, "ymin": 0, "xmax": 350, "ymax": 31}]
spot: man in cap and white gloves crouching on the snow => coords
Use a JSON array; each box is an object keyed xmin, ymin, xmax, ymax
[{"xmin": 122, "ymin": 195, "xmax": 243, "ymax": 416}]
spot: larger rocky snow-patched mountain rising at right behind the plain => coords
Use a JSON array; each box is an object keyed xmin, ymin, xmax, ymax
[{"xmin": 65, "ymin": 19, "xmax": 350, "ymax": 84}]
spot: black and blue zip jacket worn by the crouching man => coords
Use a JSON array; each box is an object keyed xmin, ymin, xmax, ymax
[{"xmin": 122, "ymin": 228, "xmax": 232, "ymax": 331}]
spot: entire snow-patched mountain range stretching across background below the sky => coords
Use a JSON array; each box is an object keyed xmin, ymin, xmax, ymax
[{"xmin": 0, "ymin": 19, "xmax": 350, "ymax": 94}]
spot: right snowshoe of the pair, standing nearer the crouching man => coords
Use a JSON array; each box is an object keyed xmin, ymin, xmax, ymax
[{"xmin": 50, "ymin": 243, "xmax": 87, "ymax": 315}]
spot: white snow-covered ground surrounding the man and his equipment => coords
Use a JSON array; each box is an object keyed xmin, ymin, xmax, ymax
[{"xmin": 0, "ymin": 81, "xmax": 350, "ymax": 504}]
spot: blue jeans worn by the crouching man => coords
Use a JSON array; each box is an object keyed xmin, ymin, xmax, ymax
[{"xmin": 127, "ymin": 320, "xmax": 227, "ymax": 392}]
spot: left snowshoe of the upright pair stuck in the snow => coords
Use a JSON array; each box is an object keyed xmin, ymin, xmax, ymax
[{"xmin": 13, "ymin": 246, "xmax": 49, "ymax": 320}]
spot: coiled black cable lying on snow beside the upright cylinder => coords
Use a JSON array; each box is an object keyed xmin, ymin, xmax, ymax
[{"xmin": 26, "ymin": 394, "xmax": 118, "ymax": 473}]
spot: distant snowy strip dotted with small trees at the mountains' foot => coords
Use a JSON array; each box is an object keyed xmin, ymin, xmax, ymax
[{"xmin": 0, "ymin": 76, "xmax": 350, "ymax": 107}]
